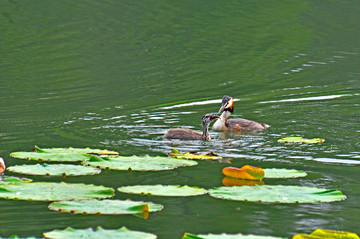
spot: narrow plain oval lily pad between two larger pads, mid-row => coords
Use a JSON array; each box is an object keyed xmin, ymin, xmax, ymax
[{"xmin": 118, "ymin": 185, "xmax": 207, "ymax": 197}]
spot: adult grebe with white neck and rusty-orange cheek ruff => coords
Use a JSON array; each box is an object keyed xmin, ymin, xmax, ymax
[{"xmin": 212, "ymin": 95, "xmax": 270, "ymax": 131}]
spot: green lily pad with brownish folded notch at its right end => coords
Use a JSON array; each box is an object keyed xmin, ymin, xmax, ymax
[{"xmin": 49, "ymin": 200, "xmax": 164, "ymax": 215}]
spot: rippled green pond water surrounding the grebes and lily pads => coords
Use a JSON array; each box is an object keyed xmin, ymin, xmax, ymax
[{"xmin": 0, "ymin": 0, "xmax": 360, "ymax": 238}]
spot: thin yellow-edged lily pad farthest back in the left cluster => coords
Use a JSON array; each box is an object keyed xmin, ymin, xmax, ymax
[{"xmin": 34, "ymin": 145, "xmax": 119, "ymax": 155}]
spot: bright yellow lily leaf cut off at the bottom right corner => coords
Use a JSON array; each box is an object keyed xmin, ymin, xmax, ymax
[{"xmin": 293, "ymin": 229, "xmax": 360, "ymax": 239}]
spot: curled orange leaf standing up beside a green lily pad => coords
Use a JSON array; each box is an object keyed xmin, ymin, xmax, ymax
[{"xmin": 222, "ymin": 165, "xmax": 265, "ymax": 180}]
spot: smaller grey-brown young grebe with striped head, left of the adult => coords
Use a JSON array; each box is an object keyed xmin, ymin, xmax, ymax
[{"xmin": 165, "ymin": 114, "xmax": 219, "ymax": 140}]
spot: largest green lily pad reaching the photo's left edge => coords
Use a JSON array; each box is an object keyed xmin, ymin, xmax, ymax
[{"xmin": 0, "ymin": 182, "xmax": 114, "ymax": 201}]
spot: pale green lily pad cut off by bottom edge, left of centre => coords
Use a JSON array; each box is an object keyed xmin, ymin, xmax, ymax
[{"xmin": 43, "ymin": 227, "xmax": 157, "ymax": 239}]
